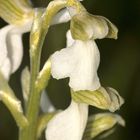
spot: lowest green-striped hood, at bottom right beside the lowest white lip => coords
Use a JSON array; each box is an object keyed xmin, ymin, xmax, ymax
[{"xmin": 83, "ymin": 113, "xmax": 125, "ymax": 140}]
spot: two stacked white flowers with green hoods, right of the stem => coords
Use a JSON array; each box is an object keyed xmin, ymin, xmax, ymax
[{"xmin": 46, "ymin": 0, "xmax": 124, "ymax": 140}]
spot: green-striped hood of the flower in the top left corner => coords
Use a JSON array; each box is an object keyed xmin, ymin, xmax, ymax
[{"xmin": 0, "ymin": 0, "xmax": 33, "ymax": 25}]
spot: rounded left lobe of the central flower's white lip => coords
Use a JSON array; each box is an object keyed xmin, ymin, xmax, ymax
[{"xmin": 51, "ymin": 44, "xmax": 76, "ymax": 79}]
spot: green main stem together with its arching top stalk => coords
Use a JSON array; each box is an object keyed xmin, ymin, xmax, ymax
[{"xmin": 19, "ymin": 1, "xmax": 66, "ymax": 140}]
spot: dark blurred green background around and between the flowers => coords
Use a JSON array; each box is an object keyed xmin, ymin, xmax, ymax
[{"xmin": 0, "ymin": 0, "xmax": 140, "ymax": 140}]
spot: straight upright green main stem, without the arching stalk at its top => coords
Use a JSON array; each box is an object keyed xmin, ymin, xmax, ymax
[{"xmin": 19, "ymin": 11, "xmax": 45, "ymax": 140}]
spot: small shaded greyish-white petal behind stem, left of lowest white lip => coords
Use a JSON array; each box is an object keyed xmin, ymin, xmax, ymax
[{"xmin": 40, "ymin": 91, "xmax": 55, "ymax": 112}]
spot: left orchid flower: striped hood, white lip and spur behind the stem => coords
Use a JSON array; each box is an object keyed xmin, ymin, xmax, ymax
[{"xmin": 0, "ymin": 0, "xmax": 71, "ymax": 80}]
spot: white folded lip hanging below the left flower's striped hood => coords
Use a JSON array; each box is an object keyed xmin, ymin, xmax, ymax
[{"xmin": 0, "ymin": 21, "xmax": 32, "ymax": 80}]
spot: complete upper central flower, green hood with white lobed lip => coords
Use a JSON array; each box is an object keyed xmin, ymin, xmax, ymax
[{"xmin": 51, "ymin": 7, "xmax": 118, "ymax": 91}]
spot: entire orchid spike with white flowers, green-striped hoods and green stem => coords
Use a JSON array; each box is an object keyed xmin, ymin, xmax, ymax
[{"xmin": 0, "ymin": 0, "xmax": 125, "ymax": 140}]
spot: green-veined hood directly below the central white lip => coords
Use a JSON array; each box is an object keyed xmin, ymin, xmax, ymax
[{"xmin": 72, "ymin": 87, "xmax": 124, "ymax": 112}]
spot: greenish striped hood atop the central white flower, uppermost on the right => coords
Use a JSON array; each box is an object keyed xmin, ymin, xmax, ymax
[{"xmin": 71, "ymin": 12, "xmax": 118, "ymax": 40}]
